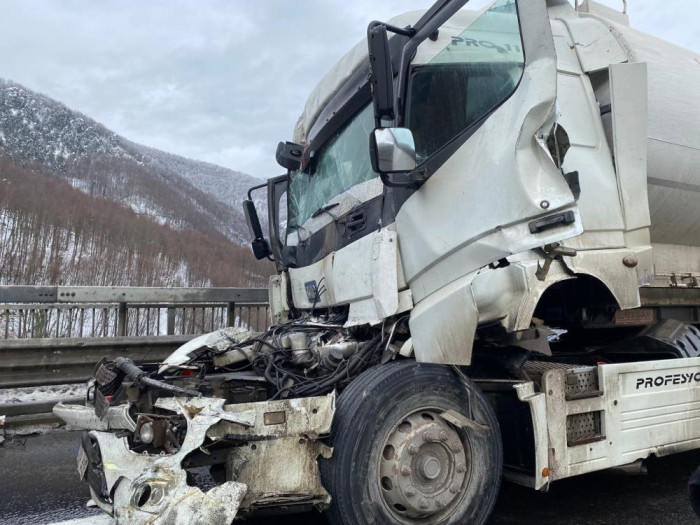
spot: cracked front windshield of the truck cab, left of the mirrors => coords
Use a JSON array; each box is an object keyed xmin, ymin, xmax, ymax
[{"xmin": 287, "ymin": 104, "xmax": 378, "ymax": 230}]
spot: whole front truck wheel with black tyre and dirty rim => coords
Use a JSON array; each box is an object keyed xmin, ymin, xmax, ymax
[{"xmin": 321, "ymin": 361, "xmax": 503, "ymax": 525}]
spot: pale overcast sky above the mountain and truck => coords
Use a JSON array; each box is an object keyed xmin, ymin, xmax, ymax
[{"xmin": 0, "ymin": 0, "xmax": 700, "ymax": 177}]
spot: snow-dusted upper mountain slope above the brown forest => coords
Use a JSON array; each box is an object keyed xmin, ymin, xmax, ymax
[{"xmin": 0, "ymin": 79, "xmax": 262, "ymax": 244}]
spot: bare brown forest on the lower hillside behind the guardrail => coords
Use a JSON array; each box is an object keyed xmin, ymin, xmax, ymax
[{"xmin": 0, "ymin": 157, "xmax": 273, "ymax": 287}]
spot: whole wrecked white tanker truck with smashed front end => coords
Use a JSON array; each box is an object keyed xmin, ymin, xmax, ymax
[{"xmin": 55, "ymin": 0, "xmax": 700, "ymax": 525}]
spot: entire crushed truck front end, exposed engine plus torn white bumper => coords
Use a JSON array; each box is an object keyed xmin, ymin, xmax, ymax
[{"xmin": 55, "ymin": 315, "xmax": 408, "ymax": 521}]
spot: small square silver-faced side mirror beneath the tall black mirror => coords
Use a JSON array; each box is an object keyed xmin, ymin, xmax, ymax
[{"xmin": 369, "ymin": 128, "xmax": 416, "ymax": 173}]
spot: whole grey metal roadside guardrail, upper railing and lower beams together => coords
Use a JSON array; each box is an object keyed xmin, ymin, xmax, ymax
[{"xmin": 0, "ymin": 286, "xmax": 270, "ymax": 428}]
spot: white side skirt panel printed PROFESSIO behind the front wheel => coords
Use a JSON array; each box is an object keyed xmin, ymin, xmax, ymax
[{"xmin": 514, "ymin": 358, "xmax": 700, "ymax": 488}]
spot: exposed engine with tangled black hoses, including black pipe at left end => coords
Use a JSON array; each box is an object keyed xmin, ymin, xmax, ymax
[{"xmin": 88, "ymin": 310, "xmax": 405, "ymax": 415}]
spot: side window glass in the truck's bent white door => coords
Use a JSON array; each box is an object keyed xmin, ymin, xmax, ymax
[{"xmin": 406, "ymin": 0, "xmax": 525, "ymax": 163}]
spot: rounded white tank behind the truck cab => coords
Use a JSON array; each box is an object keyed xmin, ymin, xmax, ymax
[{"xmin": 610, "ymin": 22, "xmax": 700, "ymax": 246}]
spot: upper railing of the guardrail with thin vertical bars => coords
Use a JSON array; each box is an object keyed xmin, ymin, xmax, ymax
[{"xmin": 0, "ymin": 286, "xmax": 269, "ymax": 339}]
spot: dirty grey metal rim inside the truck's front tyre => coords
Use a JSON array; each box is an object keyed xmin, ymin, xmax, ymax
[{"xmin": 378, "ymin": 409, "xmax": 470, "ymax": 522}]
